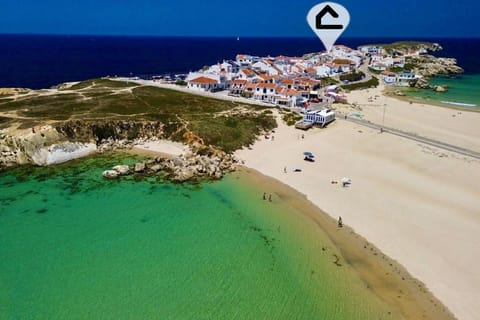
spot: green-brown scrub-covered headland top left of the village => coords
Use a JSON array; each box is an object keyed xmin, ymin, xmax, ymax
[{"xmin": 0, "ymin": 79, "xmax": 276, "ymax": 152}]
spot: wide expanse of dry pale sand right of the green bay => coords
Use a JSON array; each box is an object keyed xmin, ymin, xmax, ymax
[{"xmin": 236, "ymin": 88, "xmax": 480, "ymax": 319}]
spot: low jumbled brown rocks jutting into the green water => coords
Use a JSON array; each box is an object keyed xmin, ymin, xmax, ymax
[{"xmin": 103, "ymin": 152, "xmax": 237, "ymax": 182}]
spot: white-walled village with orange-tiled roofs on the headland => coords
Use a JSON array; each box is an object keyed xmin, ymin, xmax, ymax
[{"xmin": 145, "ymin": 42, "xmax": 463, "ymax": 128}]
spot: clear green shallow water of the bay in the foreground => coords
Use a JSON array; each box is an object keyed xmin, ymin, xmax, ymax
[{"xmin": 0, "ymin": 158, "xmax": 394, "ymax": 319}]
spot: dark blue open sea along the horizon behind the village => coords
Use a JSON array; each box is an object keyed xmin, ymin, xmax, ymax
[{"xmin": 0, "ymin": 35, "xmax": 480, "ymax": 89}]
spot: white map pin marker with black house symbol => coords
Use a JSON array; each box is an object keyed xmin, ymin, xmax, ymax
[{"xmin": 307, "ymin": 2, "xmax": 350, "ymax": 52}]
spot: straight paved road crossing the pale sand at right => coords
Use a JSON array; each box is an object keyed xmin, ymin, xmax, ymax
[{"xmin": 340, "ymin": 117, "xmax": 480, "ymax": 160}]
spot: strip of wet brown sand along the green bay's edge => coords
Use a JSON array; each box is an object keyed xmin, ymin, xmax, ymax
[{"xmin": 237, "ymin": 166, "xmax": 455, "ymax": 320}]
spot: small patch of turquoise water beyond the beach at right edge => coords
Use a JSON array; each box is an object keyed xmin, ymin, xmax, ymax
[{"xmin": 406, "ymin": 74, "xmax": 480, "ymax": 108}]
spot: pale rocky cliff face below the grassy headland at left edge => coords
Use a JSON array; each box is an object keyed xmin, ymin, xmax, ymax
[{"xmin": 0, "ymin": 120, "xmax": 163, "ymax": 169}]
